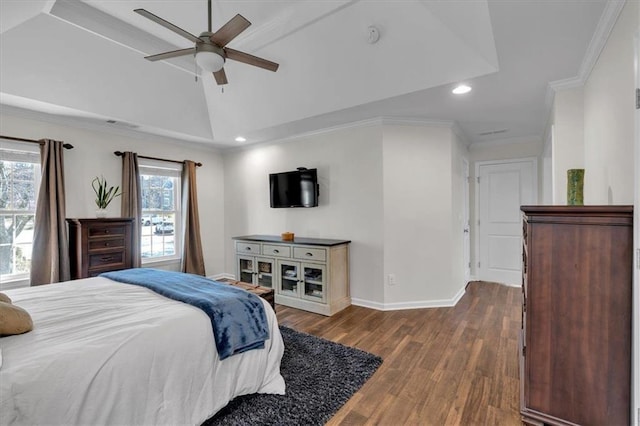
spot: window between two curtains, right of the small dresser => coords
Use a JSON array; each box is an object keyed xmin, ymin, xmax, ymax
[{"xmin": 140, "ymin": 160, "xmax": 182, "ymax": 263}]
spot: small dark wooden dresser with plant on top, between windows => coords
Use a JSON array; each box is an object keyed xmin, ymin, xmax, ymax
[{"xmin": 67, "ymin": 218, "xmax": 133, "ymax": 279}]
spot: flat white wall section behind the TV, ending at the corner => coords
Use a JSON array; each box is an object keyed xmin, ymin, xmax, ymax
[{"xmin": 221, "ymin": 126, "xmax": 384, "ymax": 306}]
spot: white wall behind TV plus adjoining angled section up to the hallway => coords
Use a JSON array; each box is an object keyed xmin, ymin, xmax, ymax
[{"xmin": 224, "ymin": 124, "xmax": 466, "ymax": 309}]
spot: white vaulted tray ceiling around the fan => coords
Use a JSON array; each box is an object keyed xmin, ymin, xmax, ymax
[{"xmin": 0, "ymin": 0, "xmax": 610, "ymax": 146}]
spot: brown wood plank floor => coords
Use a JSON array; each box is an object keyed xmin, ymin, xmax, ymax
[{"xmin": 277, "ymin": 282, "xmax": 521, "ymax": 425}]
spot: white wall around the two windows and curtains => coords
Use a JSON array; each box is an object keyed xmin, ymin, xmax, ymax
[{"xmin": 0, "ymin": 108, "xmax": 224, "ymax": 275}]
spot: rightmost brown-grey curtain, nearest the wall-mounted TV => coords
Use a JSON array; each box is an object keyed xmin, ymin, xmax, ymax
[{"xmin": 182, "ymin": 160, "xmax": 205, "ymax": 275}]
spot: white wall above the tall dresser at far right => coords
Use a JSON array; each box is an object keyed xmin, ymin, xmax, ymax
[{"xmin": 584, "ymin": 1, "xmax": 639, "ymax": 204}]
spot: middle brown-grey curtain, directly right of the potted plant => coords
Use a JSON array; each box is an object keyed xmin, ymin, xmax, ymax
[{"xmin": 120, "ymin": 151, "xmax": 142, "ymax": 268}]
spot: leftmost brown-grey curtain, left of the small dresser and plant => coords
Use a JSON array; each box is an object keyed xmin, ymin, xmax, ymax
[{"xmin": 31, "ymin": 139, "xmax": 71, "ymax": 286}]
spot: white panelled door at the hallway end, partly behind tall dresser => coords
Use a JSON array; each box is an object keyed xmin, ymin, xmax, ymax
[{"xmin": 477, "ymin": 158, "xmax": 537, "ymax": 286}]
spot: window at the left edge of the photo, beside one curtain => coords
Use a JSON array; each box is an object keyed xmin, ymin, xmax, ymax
[{"xmin": 0, "ymin": 145, "xmax": 40, "ymax": 283}]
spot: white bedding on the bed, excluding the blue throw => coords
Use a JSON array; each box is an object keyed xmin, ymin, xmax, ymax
[{"xmin": 0, "ymin": 277, "xmax": 285, "ymax": 425}]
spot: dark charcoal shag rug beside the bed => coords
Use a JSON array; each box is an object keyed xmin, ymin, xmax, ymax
[{"xmin": 203, "ymin": 326, "xmax": 382, "ymax": 426}]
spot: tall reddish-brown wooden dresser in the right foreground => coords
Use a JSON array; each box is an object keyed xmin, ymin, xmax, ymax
[{"xmin": 520, "ymin": 206, "xmax": 633, "ymax": 425}]
